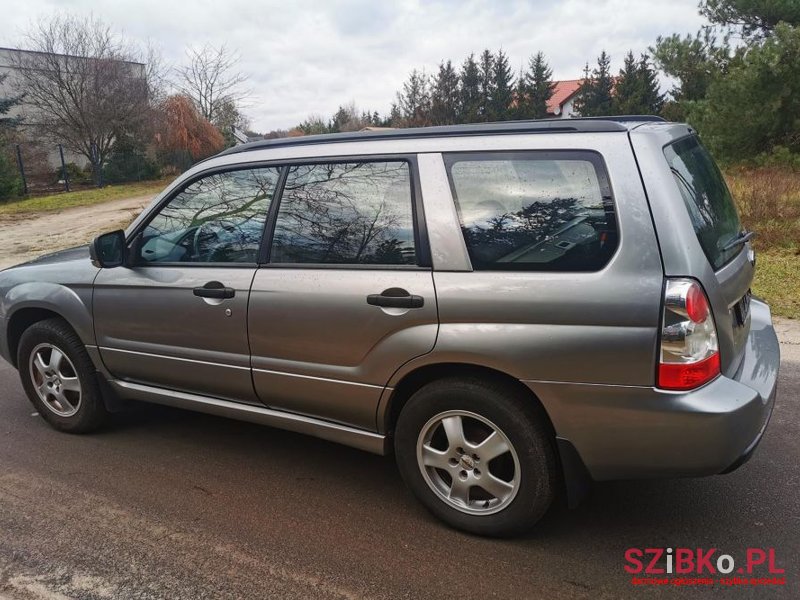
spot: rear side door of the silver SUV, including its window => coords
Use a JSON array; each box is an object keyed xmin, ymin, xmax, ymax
[{"xmin": 248, "ymin": 157, "xmax": 438, "ymax": 430}]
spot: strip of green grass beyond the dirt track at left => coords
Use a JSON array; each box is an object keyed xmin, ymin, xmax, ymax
[{"xmin": 0, "ymin": 178, "xmax": 172, "ymax": 217}]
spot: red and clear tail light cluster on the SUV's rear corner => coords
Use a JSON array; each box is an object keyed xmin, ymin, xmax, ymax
[{"xmin": 658, "ymin": 279, "xmax": 720, "ymax": 390}]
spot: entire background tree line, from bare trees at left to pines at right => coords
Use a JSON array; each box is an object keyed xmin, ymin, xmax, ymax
[{"xmin": 0, "ymin": 0, "xmax": 800, "ymax": 198}]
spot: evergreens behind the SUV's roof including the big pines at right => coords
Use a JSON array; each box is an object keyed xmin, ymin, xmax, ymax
[{"xmin": 296, "ymin": 0, "xmax": 800, "ymax": 168}]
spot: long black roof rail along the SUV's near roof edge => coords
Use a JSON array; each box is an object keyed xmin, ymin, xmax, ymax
[{"xmin": 217, "ymin": 116, "xmax": 664, "ymax": 156}]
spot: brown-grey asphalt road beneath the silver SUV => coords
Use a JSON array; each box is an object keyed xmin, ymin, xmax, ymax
[{"xmin": 0, "ymin": 336, "xmax": 800, "ymax": 600}]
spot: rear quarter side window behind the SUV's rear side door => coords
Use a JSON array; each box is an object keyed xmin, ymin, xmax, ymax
[{"xmin": 445, "ymin": 151, "xmax": 618, "ymax": 271}]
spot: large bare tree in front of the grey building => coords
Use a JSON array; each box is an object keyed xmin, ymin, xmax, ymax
[{"xmin": 13, "ymin": 15, "xmax": 158, "ymax": 181}]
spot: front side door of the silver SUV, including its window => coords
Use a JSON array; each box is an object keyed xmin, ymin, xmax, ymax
[{"xmin": 94, "ymin": 168, "xmax": 279, "ymax": 403}]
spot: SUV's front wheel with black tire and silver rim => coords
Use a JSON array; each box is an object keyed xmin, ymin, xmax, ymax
[{"xmin": 17, "ymin": 319, "xmax": 109, "ymax": 433}]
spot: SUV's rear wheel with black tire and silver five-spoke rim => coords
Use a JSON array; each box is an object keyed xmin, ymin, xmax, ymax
[{"xmin": 394, "ymin": 378, "xmax": 559, "ymax": 537}]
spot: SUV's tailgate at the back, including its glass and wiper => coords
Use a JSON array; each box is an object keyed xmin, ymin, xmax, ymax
[{"xmin": 631, "ymin": 125, "xmax": 755, "ymax": 375}]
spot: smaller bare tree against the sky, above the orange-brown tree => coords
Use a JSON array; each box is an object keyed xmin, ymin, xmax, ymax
[{"xmin": 177, "ymin": 45, "xmax": 247, "ymax": 123}]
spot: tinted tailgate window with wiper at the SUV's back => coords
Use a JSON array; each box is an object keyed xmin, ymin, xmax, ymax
[{"xmin": 664, "ymin": 137, "xmax": 742, "ymax": 271}]
